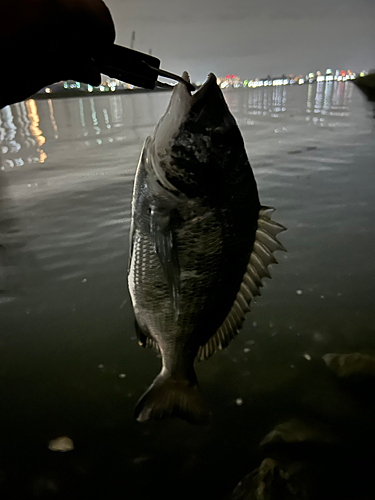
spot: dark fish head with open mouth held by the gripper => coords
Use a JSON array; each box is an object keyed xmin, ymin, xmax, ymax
[{"xmin": 151, "ymin": 72, "xmax": 248, "ymax": 197}]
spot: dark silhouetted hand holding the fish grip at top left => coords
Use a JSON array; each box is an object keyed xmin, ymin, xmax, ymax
[{"xmin": 0, "ymin": 0, "xmax": 115, "ymax": 108}]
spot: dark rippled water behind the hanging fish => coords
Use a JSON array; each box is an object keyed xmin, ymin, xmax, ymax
[{"xmin": 0, "ymin": 82, "xmax": 375, "ymax": 499}]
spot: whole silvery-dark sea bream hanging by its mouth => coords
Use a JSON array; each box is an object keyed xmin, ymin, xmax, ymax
[{"xmin": 128, "ymin": 73, "xmax": 284, "ymax": 421}]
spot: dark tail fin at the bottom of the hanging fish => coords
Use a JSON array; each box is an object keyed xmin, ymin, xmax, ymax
[{"xmin": 135, "ymin": 371, "xmax": 208, "ymax": 423}]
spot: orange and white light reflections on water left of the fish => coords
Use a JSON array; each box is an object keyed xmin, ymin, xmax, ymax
[{"xmin": 0, "ymin": 94, "xmax": 169, "ymax": 174}]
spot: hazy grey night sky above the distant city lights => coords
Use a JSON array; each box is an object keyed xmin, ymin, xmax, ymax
[{"xmin": 106, "ymin": 0, "xmax": 375, "ymax": 81}]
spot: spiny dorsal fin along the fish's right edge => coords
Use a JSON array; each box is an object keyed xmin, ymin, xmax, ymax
[{"xmin": 197, "ymin": 207, "xmax": 286, "ymax": 360}]
